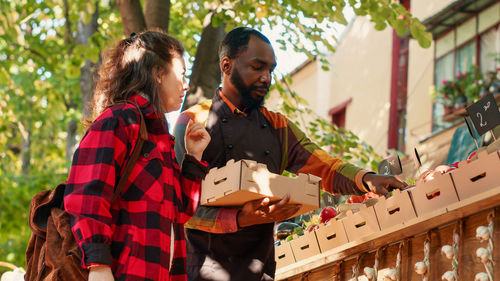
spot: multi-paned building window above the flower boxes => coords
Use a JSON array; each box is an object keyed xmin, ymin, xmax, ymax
[{"xmin": 433, "ymin": 3, "xmax": 500, "ymax": 131}]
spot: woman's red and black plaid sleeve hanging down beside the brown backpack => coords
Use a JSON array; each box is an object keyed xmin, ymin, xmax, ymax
[{"xmin": 64, "ymin": 112, "xmax": 135, "ymax": 268}]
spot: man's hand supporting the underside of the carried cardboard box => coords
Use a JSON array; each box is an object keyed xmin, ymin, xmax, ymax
[{"xmin": 237, "ymin": 194, "xmax": 300, "ymax": 227}]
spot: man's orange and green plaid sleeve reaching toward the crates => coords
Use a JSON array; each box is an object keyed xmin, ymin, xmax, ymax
[{"xmin": 262, "ymin": 109, "xmax": 367, "ymax": 195}]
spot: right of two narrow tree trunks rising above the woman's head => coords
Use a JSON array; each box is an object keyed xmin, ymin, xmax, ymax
[{"xmin": 144, "ymin": 0, "xmax": 170, "ymax": 32}]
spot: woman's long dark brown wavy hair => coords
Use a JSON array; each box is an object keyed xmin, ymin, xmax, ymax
[{"xmin": 91, "ymin": 31, "xmax": 184, "ymax": 118}]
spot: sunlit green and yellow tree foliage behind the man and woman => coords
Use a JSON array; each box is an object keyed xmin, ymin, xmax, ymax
[{"xmin": 0, "ymin": 0, "xmax": 431, "ymax": 271}]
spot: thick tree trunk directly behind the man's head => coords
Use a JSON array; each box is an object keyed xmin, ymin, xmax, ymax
[{"xmin": 183, "ymin": 15, "xmax": 226, "ymax": 110}]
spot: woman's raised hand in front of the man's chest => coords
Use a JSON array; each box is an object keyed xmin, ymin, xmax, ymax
[{"xmin": 184, "ymin": 120, "xmax": 210, "ymax": 160}]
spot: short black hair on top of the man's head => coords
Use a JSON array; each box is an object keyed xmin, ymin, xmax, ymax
[{"xmin": 219, "ymin": 27, "xmax": 271, "ymax": 61}]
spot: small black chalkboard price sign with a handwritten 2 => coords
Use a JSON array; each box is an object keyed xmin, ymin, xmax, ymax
[{"xmin": 466, "ymin": 93, "xmax": 500, "ymax": 136}]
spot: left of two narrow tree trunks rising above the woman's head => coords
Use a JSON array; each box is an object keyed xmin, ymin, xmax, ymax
[{"xmin": 116, "ymin": 0, "xmax": 146, "ymax": 36}]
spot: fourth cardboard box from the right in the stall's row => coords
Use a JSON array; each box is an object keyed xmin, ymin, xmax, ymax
[{"xmin": 342, "ymin": 204, "xmax": 380, "ymax": 242}]
